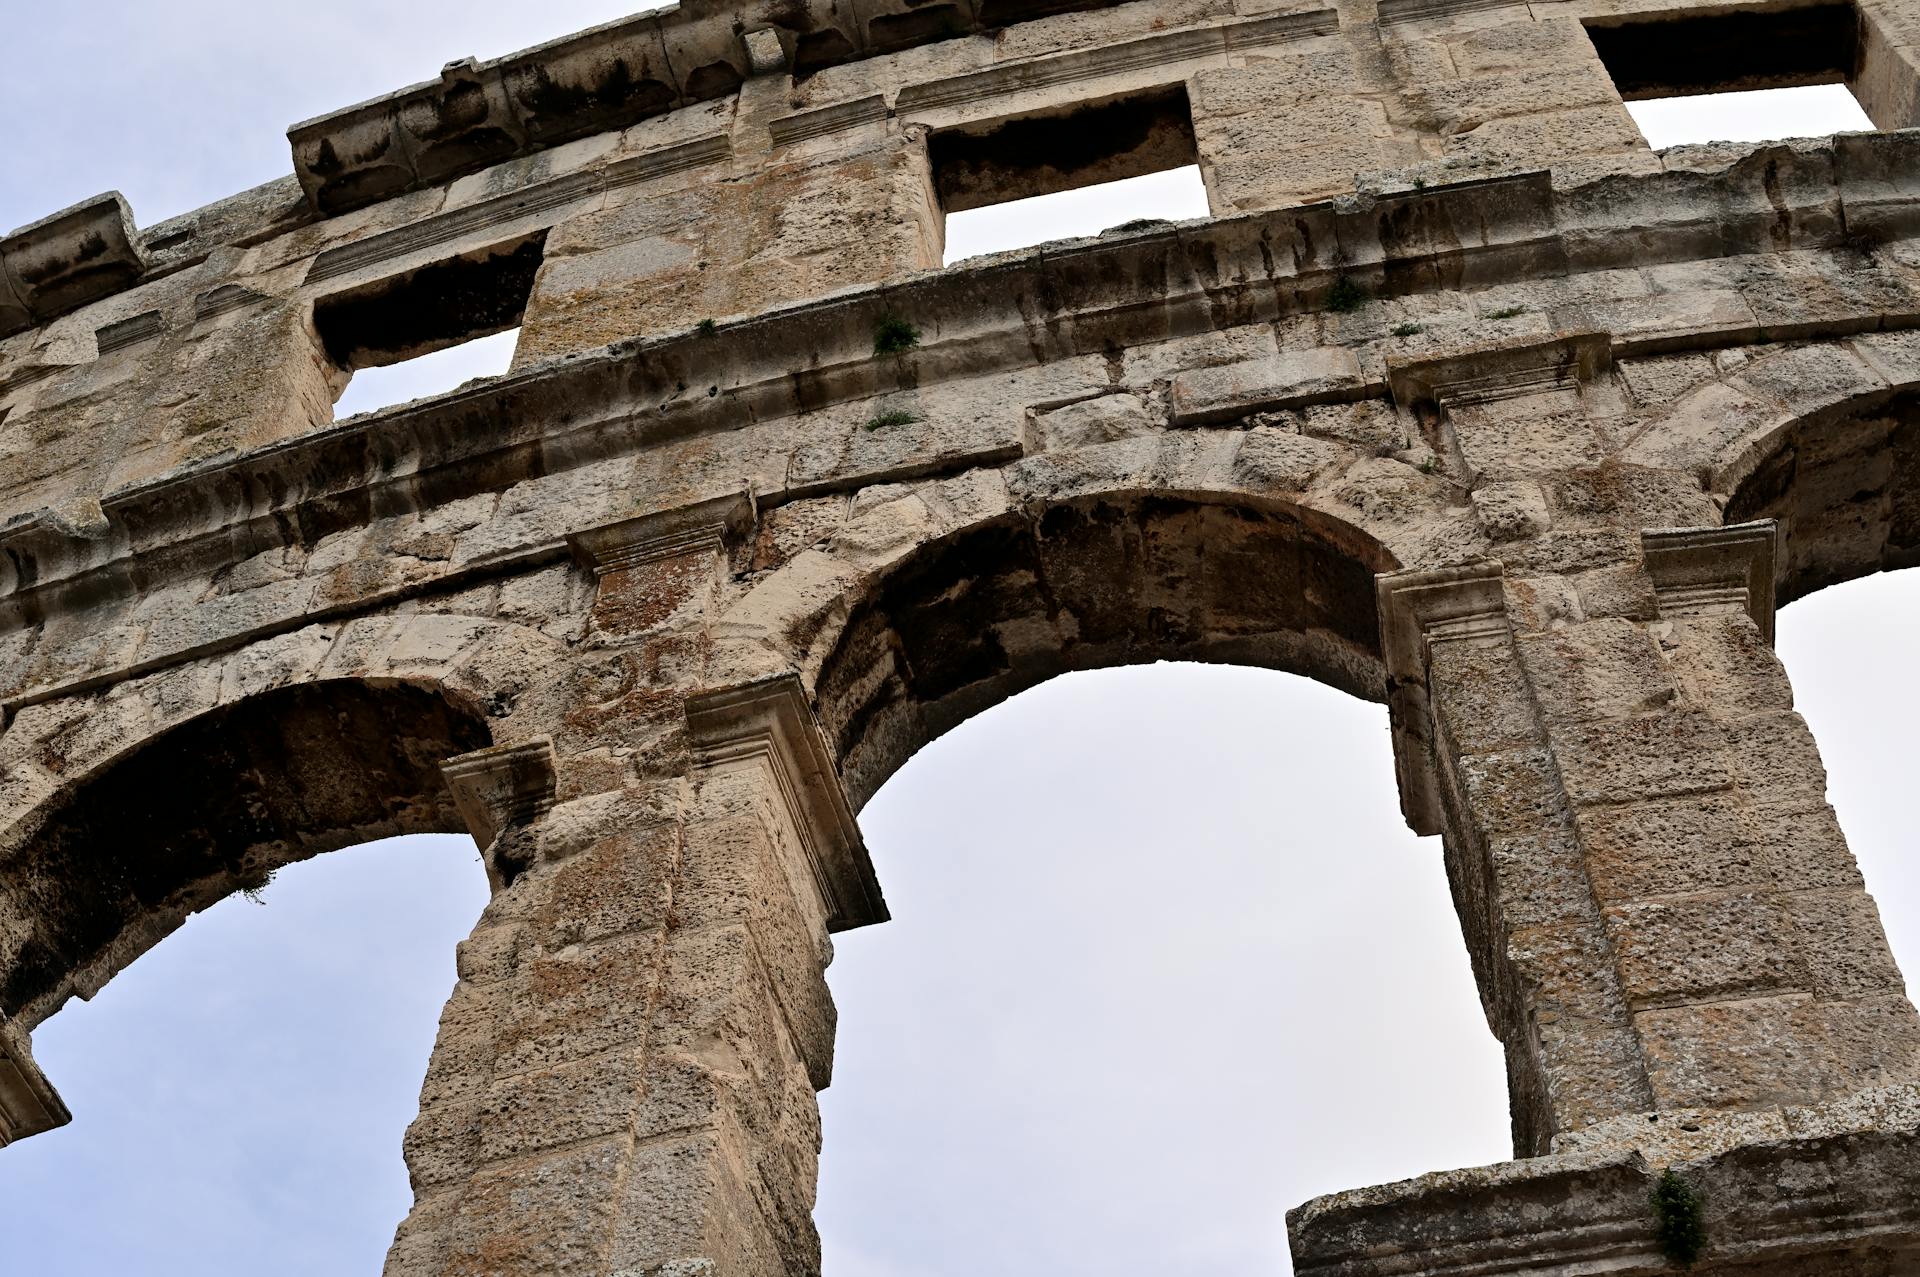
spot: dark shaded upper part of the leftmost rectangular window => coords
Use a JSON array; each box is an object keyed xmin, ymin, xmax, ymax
[{"xmin": 313, "ymin": 230, "xmax": 547, "ymax": 369}]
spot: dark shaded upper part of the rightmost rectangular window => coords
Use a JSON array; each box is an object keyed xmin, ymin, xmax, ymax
[{"xmin": 1586, "ymin": 4, "xmax": 1860, "ymax": 102}]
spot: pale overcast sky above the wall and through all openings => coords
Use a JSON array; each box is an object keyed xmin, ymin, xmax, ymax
[{"xmin": 0, "ymin": 0, "xmax": 1896, "ymax": 1277}]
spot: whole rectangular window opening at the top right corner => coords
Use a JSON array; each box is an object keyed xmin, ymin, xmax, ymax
[{"xmin": 1586, "ymin": 0, "xmax": 1889, "ymax": 148}]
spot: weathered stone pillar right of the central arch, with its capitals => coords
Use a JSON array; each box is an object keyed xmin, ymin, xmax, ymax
[{"xmin": 1380, "ymin": 524, "xmax": 1920, "ymax": 1156}]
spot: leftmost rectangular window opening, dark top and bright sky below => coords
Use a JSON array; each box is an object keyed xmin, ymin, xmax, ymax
[{"xmin": 313, "ymin": 230, "xmax": 547, "ymax": 419}]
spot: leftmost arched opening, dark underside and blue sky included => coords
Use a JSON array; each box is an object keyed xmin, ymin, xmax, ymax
[{"xmin": 0, "ymin": 680, "xmax": 490, "ymax": 1273}]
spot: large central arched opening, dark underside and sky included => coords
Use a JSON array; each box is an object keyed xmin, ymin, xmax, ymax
[{"xmin": 794, "ymin": 494, "xmax": 1509, "ymax": 1277}]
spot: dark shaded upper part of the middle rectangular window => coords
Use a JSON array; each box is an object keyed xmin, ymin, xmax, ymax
[{"xmin": 927, "ymin": 84, "xmax": 1198, "ymax": 213}]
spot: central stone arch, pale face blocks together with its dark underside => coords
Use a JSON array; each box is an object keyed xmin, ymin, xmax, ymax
[{"xmin": 708, "ymin": 428, "xmax": 1486, "ymax": 808}]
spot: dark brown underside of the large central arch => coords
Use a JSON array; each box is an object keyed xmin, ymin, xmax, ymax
[{"xmin": 816, "ymin": 495, "xmax": 1394, "ymax": 808}]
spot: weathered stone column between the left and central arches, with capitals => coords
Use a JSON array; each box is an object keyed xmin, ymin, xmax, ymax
[{"xmin": 388, "ymin": 499, "xmax": 883, "ymax": 1277}]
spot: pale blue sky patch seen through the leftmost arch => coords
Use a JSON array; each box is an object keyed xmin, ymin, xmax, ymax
[{"xmin": 0, "ymin": 833, "xmax": 488, "ymax": 1277}]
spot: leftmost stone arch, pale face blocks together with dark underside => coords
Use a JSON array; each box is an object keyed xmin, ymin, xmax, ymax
[{"xmin": 0, "ymin": 614, "xmax": 553, "ymax": 1031}]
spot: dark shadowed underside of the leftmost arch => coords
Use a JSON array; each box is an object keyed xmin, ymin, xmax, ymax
[{"xmin": 0, "ymin": 678, "xmax": 492, "ymax": 1029}]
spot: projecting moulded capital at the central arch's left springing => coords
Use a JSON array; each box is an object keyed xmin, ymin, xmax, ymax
[{"xmin": 687, "ymin": 674, "xmax": 887, "ymax": 931}]
